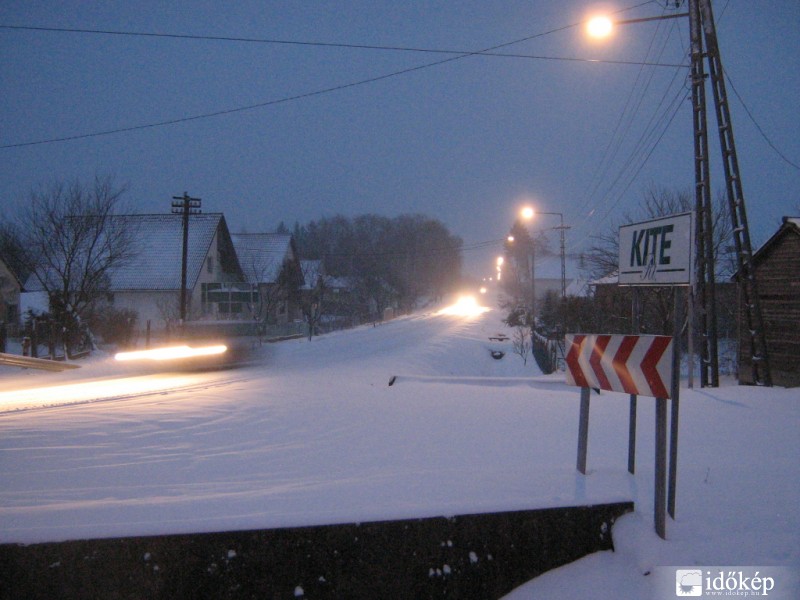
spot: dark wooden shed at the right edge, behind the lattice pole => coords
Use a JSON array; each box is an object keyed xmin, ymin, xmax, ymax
[{"xmin": 739, "ymin": 231, "xmax": 800, "ymax": 387}]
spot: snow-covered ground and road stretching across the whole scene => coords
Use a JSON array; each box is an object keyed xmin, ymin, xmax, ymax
[{"xmin": 0, "ymin": 290, "xmax": 800, "ymax": 600}]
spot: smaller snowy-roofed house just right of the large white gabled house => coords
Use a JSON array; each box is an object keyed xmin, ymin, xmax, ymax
[{"xmin": 231, "ymin": 233, "xmax": 304, "ymax": 325}]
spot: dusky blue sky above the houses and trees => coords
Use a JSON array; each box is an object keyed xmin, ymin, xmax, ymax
[{"xmin": 0, "ymin": 0, "xmax": 800, "ymax": 275}]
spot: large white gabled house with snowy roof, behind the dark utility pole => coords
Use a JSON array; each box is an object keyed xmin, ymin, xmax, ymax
[{"xmin": 26, "ymin": 213, "xmax": 251, "ymax": 329}]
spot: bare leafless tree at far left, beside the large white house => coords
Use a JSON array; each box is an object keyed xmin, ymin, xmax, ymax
[{"xmin": 19, "ymin": 177, "xmax": 135, "ymax": 346}]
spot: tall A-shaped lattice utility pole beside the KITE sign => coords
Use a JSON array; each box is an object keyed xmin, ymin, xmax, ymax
[{"xmin": 688, "ymin": 0, "xmax": 772, "ymax": 386}]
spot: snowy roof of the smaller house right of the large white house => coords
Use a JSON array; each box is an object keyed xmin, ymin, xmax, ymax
[{"xmin": 231, "ymin": 233, "xmax": 294, "ymax": 283}]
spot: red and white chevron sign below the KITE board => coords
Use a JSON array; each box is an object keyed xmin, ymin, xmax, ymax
[{"xmin": 565, "ymin": 333, "xmax": 672, "ymax": 398}]
